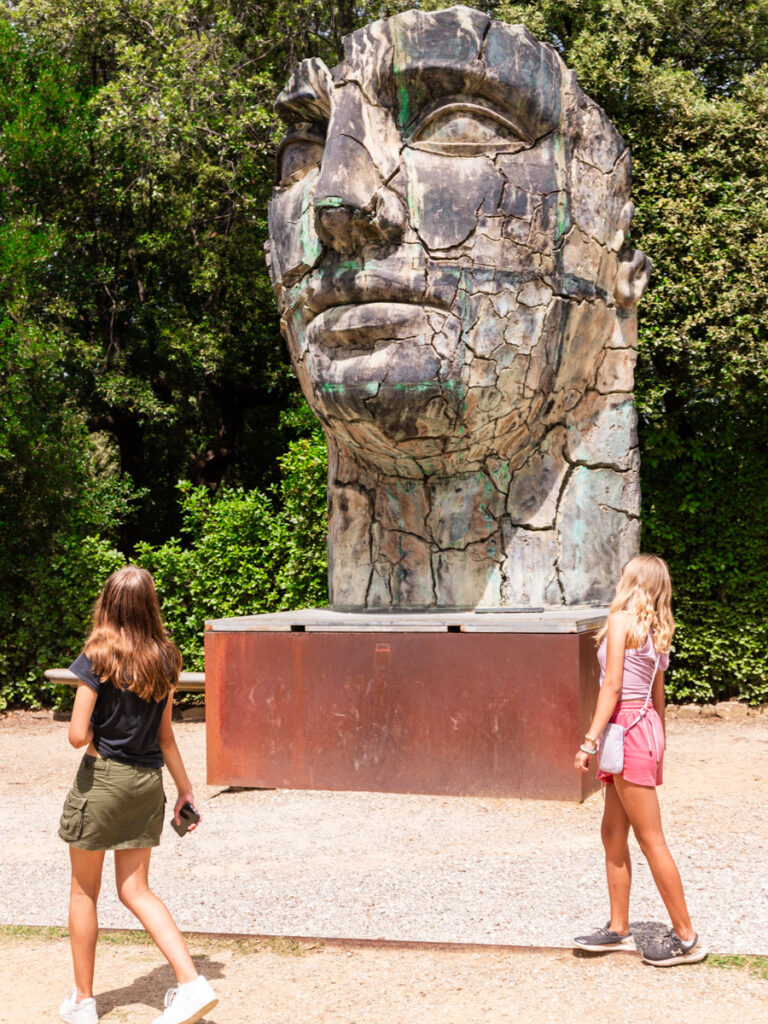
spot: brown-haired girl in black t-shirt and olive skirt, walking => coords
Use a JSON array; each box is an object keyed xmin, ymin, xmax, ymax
[{"xmin": 58, "ymin": 565, "xmax": 217, "ymax": 1024}]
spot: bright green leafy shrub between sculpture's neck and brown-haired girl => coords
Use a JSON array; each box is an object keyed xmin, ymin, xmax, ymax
[{"xmin": 136, "ymin": 419, "xmax": 328, "ymax": 671}]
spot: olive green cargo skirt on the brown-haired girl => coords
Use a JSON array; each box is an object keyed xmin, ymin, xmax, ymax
[{"xmin": 58, "ymin": 754, "xmax": 165, "ymax": 850}]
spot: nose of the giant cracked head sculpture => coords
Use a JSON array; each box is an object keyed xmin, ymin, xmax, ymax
[{"xmin": 313, "ymin": 84, "xmax": 406, "ymax": 254}]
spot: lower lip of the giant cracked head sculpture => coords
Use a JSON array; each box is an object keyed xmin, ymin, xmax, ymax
[{"xmin": 307, "ymin": 302, "xmax": 445, "ymax": 349}]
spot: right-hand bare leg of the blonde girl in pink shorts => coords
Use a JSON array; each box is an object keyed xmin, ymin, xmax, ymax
[{"xmin": 613, "ymin": 775, "xmax": 695, "ymax": 942}]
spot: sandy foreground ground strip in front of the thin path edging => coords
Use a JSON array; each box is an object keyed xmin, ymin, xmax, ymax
[{"xmin": 0, "ymin": 930, "xmax": 768, "ymax": 1024}]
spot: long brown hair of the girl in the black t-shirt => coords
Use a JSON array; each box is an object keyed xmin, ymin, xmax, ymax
[{"xmin": 85, "ymin": 565, "xmax": 181, "ymax": 700}]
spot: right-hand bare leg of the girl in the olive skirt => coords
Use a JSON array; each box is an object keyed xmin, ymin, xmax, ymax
[{"xmin": 115, "ymin": 847, "xmax": 198, "ymax": 985}]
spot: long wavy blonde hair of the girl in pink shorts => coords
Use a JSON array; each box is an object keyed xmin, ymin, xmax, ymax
[{"xmin": 596, "ymin": 555, "xmax": 675, "ymax": 651}]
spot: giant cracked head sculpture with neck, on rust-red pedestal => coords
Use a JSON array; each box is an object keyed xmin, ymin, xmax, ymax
[{"xmin": 267, "ymin": 7, "xmax": 650, "ymax": 609}]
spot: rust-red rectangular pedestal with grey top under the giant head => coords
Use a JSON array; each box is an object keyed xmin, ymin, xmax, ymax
[{"xmin": 206, "ymin": 607, "xmax": 605, "ymax": 801}]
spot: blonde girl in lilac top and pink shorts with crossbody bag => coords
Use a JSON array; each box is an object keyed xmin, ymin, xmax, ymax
[{"xmin": 574, "ymin": 555, "xmax": 707, "ymax": 967}]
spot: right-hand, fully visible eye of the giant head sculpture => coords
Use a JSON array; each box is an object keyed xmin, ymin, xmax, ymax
[{"xmin": 410, "ymin": 100, "xmax": 531, "ymax": 157}]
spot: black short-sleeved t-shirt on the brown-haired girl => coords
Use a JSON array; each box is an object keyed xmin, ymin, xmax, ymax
[{"xmin": 70, "ymin": 651, "xmax": 168, "ymax": 768}]
